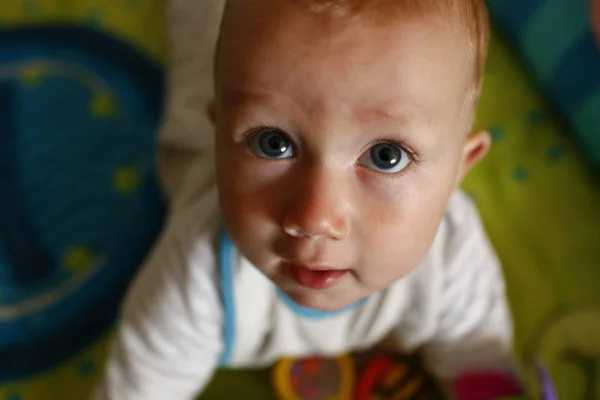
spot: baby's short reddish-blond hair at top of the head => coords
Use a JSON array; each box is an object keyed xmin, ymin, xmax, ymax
[{"xmin": 217, "ymin": 0, "xmax": 489, "ymax": 97}]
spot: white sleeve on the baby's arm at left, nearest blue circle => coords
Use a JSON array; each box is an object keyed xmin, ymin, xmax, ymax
[{"xmin": 93, "ymin": 191, "xmax": 223, "ymax": 400}]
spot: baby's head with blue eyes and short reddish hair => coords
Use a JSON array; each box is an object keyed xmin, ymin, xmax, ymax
[{"xmin": 211, "ymin": 0, "xmax": 490, "ymax": 310}]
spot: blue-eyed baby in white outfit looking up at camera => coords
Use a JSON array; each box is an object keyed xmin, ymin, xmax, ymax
[{"xmin": 95, "ymin": 0, "xmax": 512, "ymax": 400}]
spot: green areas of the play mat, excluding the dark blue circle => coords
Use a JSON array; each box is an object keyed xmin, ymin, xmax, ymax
[{"xmin": 0, "ymin": 0, "xmax": 600, "ymax": 400}]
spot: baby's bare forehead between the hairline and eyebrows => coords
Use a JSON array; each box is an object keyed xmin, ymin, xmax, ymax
[{"xmin": 216, "ymin": 0, "xmax": 471, "ymax": 126}]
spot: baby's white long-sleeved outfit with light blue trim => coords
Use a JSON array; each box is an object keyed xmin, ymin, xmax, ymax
[{"xmin": 95, "ymin": 0, "xmax": 512, "ymax": 400}]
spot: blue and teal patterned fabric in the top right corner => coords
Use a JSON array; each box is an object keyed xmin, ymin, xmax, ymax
[{"xmin": 487, "ymin": 0, "xmax": 600, "ymax": 170}]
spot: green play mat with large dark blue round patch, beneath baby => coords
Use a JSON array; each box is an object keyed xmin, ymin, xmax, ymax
[{"xmin": 0, "ymin": 0, "xmax": 600, "ymax": 400}]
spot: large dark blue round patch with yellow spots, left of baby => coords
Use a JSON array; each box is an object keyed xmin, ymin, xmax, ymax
[{"xmin": 0, "ymin": 26, "xmax": 163, "ymax": 382}]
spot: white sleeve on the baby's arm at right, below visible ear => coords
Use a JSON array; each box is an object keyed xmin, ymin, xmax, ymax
[{"xmin": 424, "ymin": 193, "xmax": 513, "ymax": 379}]
